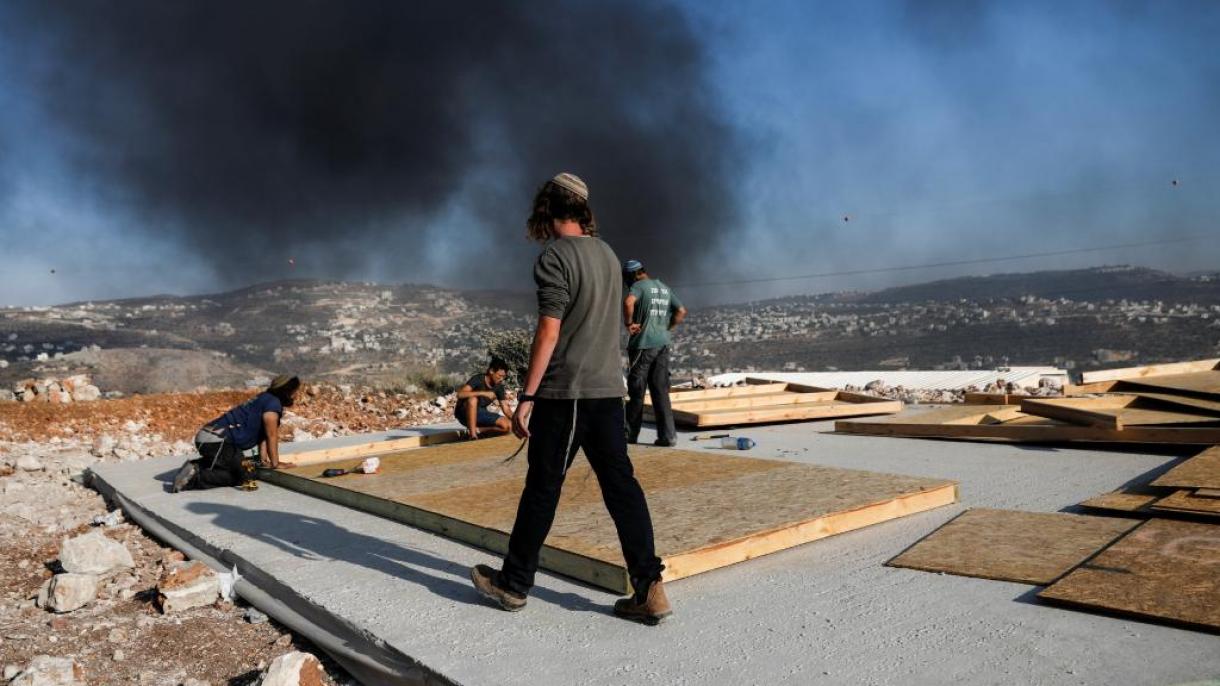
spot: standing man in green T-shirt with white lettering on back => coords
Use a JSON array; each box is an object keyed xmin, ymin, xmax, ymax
[{"xmin": 622, "ymin": 260, "xmax": 686, "ymax": 447}]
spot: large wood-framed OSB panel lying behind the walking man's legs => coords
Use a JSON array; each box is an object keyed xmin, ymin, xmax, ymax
[{"xmin": 266, "ymin": 437, "xmax": 956, "ymax": 591}]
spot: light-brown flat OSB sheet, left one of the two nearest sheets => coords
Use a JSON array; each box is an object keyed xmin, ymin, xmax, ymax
[{"xmin": 886, "ymin": 509, "xmax": 1139, "ymax": 586}]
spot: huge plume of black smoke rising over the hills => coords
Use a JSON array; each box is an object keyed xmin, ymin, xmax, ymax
[{"xmin": 0, "ymin": 0, "xmax": 738, "ymax": 287}]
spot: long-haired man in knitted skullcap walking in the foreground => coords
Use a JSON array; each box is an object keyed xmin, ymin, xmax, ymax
[{"xmin": 471, "ymin": 173, "xmax": 671, "ymax": 624}]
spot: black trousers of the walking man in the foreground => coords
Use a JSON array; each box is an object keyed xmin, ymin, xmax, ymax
[{"xmin": 501, "ymin": 398, "xmax": 665, "ymax": 593}]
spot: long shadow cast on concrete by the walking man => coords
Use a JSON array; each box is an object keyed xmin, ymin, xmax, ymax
[{"xmin": 187, "ymin": 502, "xmax": 610, "ymax": 614}]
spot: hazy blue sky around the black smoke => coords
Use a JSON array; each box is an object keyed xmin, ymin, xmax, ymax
[{"xmin": 0, "ymin": 1, "xmax": 1220, "ymax": 304}]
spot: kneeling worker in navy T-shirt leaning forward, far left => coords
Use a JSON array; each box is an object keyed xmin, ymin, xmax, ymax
[{"xmin": 173, "ymin": 376, "xmax": 301, "ymax": 493}]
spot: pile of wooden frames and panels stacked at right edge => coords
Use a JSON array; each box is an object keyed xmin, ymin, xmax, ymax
[{"xmin": 836, "ymin": 360, "xmax": 1220, "ymax": 446}]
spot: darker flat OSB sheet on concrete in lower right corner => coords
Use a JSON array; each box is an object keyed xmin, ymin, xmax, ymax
[{"xmin": 1038, "ymin": 519, "xmax": 1220, "ymax": 631}]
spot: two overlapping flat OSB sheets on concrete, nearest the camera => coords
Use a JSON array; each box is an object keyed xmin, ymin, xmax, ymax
[{"xmin": 888, "ymin": 509, "xmax": 1220, "ymax": 631}]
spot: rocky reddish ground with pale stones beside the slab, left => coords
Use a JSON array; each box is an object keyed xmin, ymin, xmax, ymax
[{"xmin": 0, "ymin": 386, "xmax": 453, "ymax": 686}]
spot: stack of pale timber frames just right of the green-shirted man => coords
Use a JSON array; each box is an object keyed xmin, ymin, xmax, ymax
[{"xmin": 644, "ymin": 380, "xmax": 903, "ymax": 427}]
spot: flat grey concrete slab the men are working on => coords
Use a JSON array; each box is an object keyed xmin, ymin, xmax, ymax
[{"xmin": 96, "ymin": 422, "xmax": 1220, "ymax": 685}]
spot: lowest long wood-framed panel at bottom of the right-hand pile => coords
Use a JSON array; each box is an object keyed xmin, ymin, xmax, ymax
[{"xmin": 834, "ymin": 405, "xmax": 1220, "ymax": 446}]
